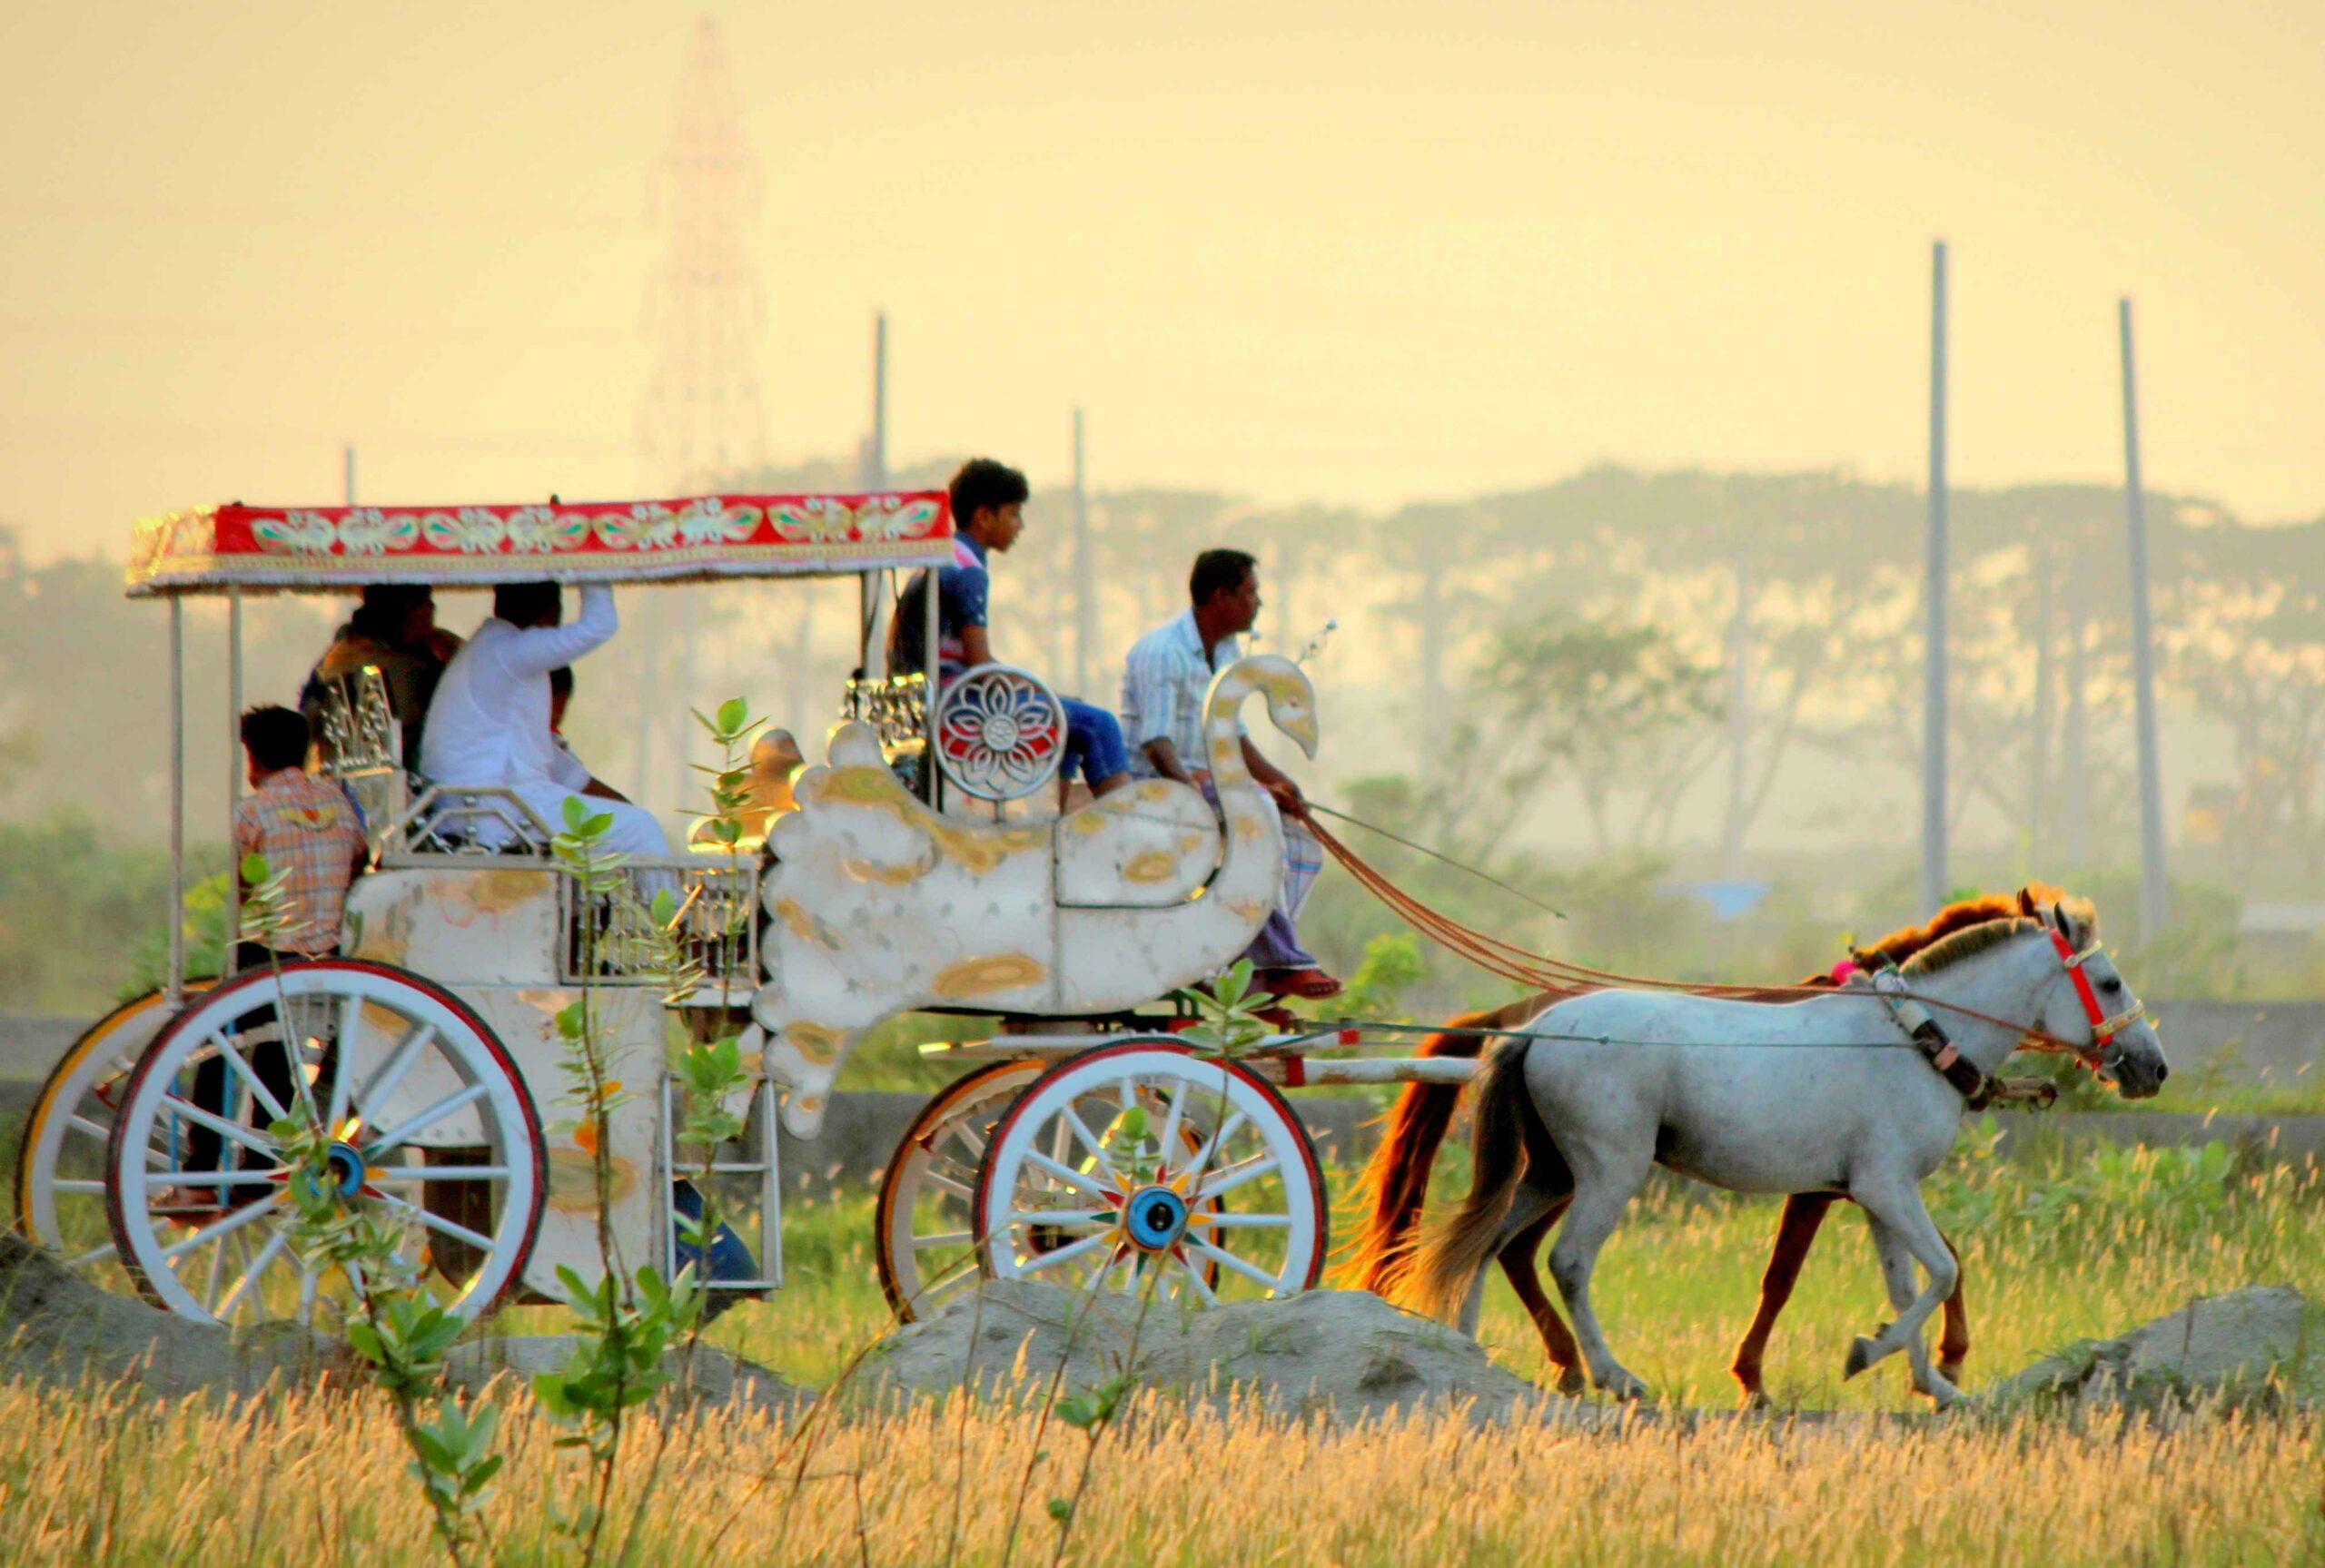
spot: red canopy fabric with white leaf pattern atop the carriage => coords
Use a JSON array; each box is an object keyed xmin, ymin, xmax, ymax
[{"xmin": 128, "ymin": 490, "xmax": 954, "ymax": 597}]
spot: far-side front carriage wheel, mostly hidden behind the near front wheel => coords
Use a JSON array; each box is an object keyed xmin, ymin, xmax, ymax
[{"xmin": 875, "ymin": 1061, "xmax": 1042, "ymax": 1324}]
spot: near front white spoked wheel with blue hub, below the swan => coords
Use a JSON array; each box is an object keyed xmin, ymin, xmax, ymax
[{"xmin": 976, "ymin": 1043, "xmax": 1325, "ymax": 1306}]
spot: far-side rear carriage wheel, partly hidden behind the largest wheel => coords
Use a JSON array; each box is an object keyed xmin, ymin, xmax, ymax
[{"xmin": 16, "ymin": 981, "xmax": 209, "ymax": 1289}]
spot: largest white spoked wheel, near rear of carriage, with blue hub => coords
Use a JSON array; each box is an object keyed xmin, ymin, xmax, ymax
[{"xmin": 104, "ymin": 960, "xmax": 549, "ymax": 1328}]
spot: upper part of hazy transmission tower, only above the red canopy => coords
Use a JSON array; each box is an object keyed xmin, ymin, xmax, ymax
[{"xmin": 637, "ymin": 16, "xmax": 767, "ymax": 490}]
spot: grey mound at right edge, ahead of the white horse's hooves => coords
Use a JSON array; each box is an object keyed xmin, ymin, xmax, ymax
[{"xmin": 1988, "ymin": 1285, "xmax": 2307, "ymax": 1407}]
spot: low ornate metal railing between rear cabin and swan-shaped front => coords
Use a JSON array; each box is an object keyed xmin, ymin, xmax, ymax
[{"xmin": 558, "ymin": 855, "xmax": 758, "ymax": 1006}]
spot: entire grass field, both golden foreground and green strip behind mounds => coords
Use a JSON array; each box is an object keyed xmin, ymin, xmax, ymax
[{"xmin": 14, "ymin": 1105, "xmax": 2325, "ymax": 1568}]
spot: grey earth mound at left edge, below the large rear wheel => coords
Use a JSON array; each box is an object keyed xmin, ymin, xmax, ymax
[{"xmin": 0, "ymin": 1236, "xmax": 362, "ymax": 1398}]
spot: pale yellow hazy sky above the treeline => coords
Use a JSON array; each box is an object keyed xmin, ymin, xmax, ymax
[{"xmin": 0, "ymin": 0, "xmax": 2325, "ymax": 564}]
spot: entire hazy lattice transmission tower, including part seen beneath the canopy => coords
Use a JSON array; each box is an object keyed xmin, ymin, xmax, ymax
[{"xmin": 632, "ymin": 16, "xmax": 767, "ymax": 808}]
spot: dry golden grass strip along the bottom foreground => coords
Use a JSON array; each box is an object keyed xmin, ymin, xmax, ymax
[{"xmin": 0, "ymin": 1386, "xmax": 2325, "ymax": 1568}]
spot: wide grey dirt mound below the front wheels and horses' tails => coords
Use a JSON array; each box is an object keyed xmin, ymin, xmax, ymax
[{"xmin": 851, "ymin": 1280, "xmax": 1590, "ymax": 1419}]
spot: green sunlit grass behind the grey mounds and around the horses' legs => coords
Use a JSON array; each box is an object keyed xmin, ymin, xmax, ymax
[{"xmin": 665, "ymin": 1124, "xmax": 2325, "ymax": 1410}]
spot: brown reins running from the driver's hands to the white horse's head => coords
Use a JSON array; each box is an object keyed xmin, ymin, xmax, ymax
[{"xmin": 1307, "ymin": 808, "xmax": 2143, "ymax": 1066}]
